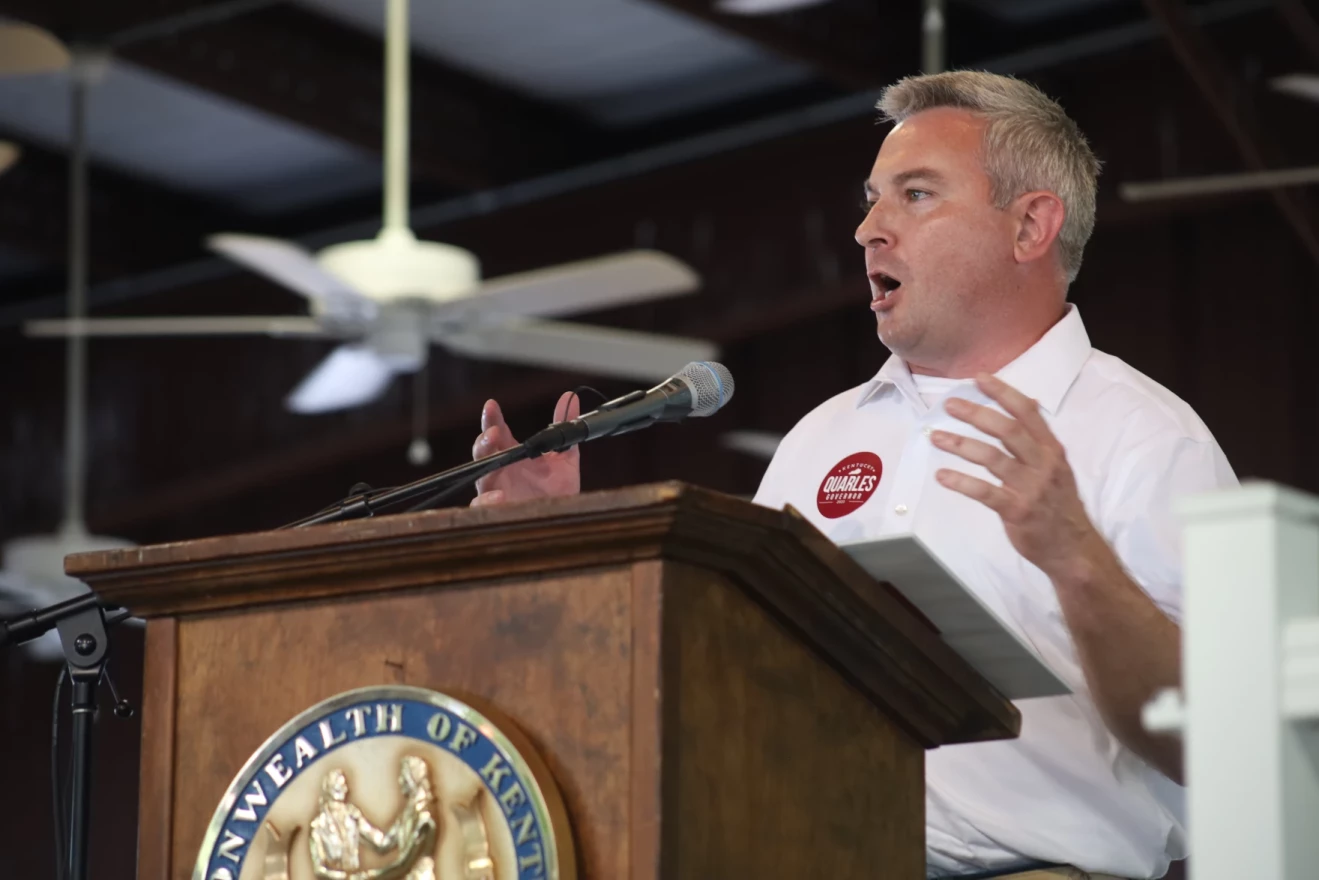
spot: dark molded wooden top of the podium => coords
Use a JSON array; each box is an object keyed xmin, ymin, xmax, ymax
[{"xmin": 65, "ymin": 483, "xmax": 1020, "ymax": 744}]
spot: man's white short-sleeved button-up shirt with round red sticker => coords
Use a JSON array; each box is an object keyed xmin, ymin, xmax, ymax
[{"xmin": 756, "ymin": 306, "xmax": 1236, "ymax": 877}]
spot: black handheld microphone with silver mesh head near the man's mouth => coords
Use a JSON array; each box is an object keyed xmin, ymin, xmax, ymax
[{"xmin": 522, "ymin": 360, "xmax": 733, "ymax": 456}]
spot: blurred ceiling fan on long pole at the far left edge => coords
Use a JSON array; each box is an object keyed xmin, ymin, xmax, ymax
[{"xmin": 0, "ymin": 46, "xmax": 132, "ymax": 660}]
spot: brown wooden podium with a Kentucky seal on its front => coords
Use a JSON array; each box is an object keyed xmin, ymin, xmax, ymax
[{"xmin": 67, "ymin": 484, "xmax": 1020, "ymax": 880}]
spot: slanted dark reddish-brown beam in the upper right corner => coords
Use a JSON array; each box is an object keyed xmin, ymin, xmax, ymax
[{"xmin": 1145, "ymin": 0, "xmax": 1319, "ymax": 263}]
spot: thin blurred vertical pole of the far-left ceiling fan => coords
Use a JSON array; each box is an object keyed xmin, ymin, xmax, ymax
[{"xmin": 62, "ymin": 65, "xmax": 91, "ymax": 530}]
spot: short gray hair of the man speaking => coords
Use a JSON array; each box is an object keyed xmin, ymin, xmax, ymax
[{"xmin": 878, "ymin": 70, "xmax": 1100, "ymax": 281}]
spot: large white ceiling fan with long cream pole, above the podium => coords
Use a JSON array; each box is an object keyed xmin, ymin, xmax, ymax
[{"xmin": 26, "ymin": 0, "xmax": 718, "ymax": 463}]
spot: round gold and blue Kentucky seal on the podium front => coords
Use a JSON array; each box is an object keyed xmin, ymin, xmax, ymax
[{"xmin": 193, "ymin": 687, "xmax": 575, "ymax": 880}]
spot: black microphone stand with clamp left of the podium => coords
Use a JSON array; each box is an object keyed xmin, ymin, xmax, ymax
[{"xmin": 0, "ymin": 592, "xmax": 132, "ymax": 880}]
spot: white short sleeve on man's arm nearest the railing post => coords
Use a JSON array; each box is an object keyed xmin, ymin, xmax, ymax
[{"xmin": 1103, "ymin": 435, "xmax": 1237, "ymax": 621}]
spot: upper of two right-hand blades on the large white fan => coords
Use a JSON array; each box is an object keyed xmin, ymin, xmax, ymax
[{"xmin": 463, "ymin": 251, "xmax": 700, "ymax": 320}]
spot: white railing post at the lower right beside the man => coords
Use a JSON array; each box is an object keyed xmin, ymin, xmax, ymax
[{"xmin": 1145, "ymin": 483, "xmax": 1319, "ymax": 880}]
